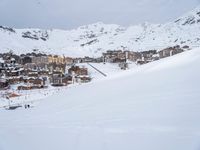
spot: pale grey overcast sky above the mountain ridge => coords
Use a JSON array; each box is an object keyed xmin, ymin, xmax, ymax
[{"xmin": 0, "ymin": 0, "xmax": 200, "ymax": 29}]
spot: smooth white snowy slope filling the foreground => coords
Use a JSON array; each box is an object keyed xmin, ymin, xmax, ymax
[{"xmin": 0, "ymin": 49, "xmax": 200, "ymax": 150}]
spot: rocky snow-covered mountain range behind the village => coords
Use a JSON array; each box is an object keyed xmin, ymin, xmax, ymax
[{"xmin": 0, "ymin": 6, "xmax": 200, "ymax": 56}]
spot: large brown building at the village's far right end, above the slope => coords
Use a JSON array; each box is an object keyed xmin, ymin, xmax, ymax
[{"xmin": 158, "ymin": 45, "xmax": 183, "ymax": 58}]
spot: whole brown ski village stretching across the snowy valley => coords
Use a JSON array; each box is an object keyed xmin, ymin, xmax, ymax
[{"xmin": 0, "ymin": 45, "xmax": 189, "ymax": 108}]
